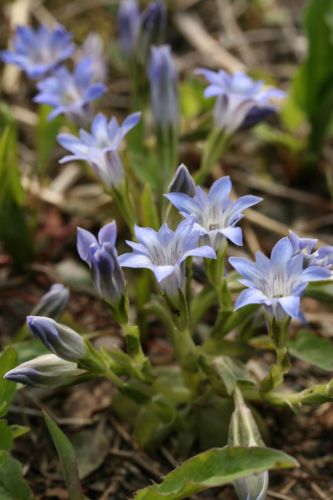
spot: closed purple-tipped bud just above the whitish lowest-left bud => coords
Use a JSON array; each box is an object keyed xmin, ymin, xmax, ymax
[{"xmin": 27, "ymin": 316, "xmax": 88, "ymax": 361}]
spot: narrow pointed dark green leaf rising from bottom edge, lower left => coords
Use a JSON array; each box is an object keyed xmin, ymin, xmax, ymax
[{"xmin": 43, "ymin": 411, "xmax": 84, "ymax": 500}]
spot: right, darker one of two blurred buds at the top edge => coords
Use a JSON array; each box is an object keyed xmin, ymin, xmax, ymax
[{"xmin": 138, "ymin": 0, "xmax": 166, "ymax": 64}]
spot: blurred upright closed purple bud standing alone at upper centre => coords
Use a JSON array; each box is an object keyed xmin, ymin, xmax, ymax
[{"xmin": 148, "ymin": 45, "xmax": 179, "ymax": 129}]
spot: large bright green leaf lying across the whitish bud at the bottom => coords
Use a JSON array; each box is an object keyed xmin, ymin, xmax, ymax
[{"xmin": 135, "ymin": 446, "xmax": 297, "ymax": 500}]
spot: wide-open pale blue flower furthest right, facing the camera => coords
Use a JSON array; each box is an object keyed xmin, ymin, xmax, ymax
[{"xmin": 229, "ymin": 238, "xmax": 330, "ymax": 320}]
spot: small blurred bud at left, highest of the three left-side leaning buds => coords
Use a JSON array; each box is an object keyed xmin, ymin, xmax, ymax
[{"xmin": 31, "ymin": 283, "xmax": 69, "ymax": 319}]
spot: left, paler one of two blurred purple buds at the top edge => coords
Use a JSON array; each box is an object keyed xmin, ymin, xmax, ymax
[{"xmin": 118, "ymin": 0, "xmax": 141, "ymax": 57}]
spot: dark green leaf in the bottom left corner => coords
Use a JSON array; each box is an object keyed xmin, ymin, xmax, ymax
[{"xmin": 0, "ymin": 451, "xmax": 33, "ymax": 500}]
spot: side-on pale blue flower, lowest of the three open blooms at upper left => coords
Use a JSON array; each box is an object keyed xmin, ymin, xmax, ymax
[{"xmin": 58, "ymin": 113, "xmax": 141, "ymax": 187}]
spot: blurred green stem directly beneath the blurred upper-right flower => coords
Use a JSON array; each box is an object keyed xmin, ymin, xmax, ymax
[{"xmin": 194, "ymin": 128, "xmax": 230, "ymax": 184}]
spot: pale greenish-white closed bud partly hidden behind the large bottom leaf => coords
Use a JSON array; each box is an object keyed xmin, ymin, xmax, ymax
[{"xmin": 228, "ymin": 390, "xmax": 268, "ymax": 500}]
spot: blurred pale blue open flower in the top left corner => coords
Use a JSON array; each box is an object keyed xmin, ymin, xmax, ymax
[{"xmin": 1, "ymin": 25, "xmax": 74, "ymax": 79}]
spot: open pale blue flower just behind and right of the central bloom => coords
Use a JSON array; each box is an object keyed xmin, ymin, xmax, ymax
[{"xmin": 165, "ymin": 177, "xmax": 262, "ymax": 254}]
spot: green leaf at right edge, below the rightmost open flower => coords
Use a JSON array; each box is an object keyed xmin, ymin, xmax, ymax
[{"xmin": 288, "ymin": 330, "xmax": 333, "ymax": 371}]
